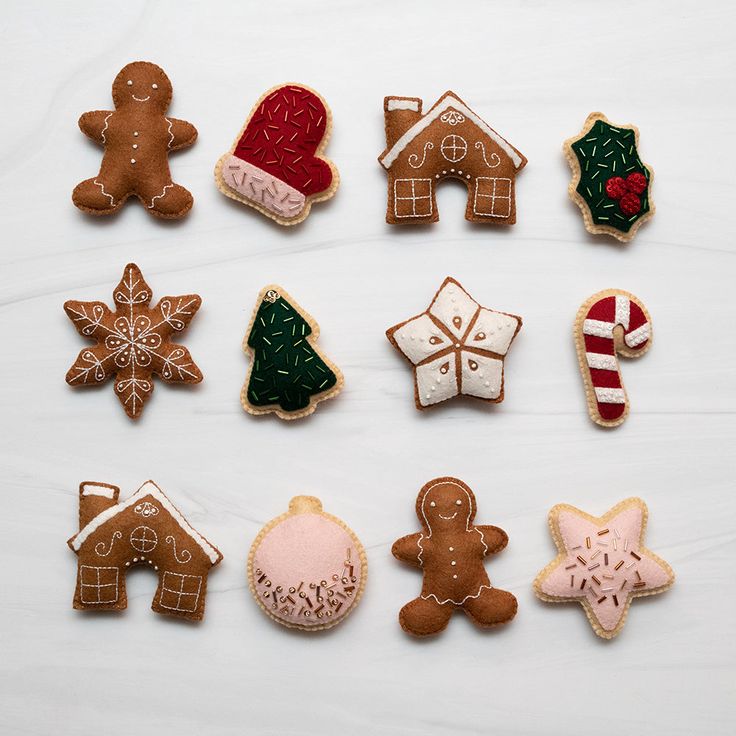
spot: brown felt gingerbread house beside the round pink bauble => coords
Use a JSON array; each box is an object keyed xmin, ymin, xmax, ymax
[{"xmin": 68, "ymin": 480, "xmax": 222, "ymax": 621}]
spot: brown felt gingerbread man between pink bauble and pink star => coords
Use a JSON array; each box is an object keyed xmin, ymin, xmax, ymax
[{"xmin": 391, "ymin": 478, "xmax": 517, "ymax": 636}]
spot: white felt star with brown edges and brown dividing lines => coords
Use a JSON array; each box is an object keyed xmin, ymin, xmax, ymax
[{"xmin": 386, "ymin": 277, "xmax": 521, "ymax": 409}]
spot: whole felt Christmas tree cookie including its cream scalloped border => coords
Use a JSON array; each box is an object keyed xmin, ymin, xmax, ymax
[{"xmin": 240, "ymin": 285, "xmax": 343, "ymax": 419}]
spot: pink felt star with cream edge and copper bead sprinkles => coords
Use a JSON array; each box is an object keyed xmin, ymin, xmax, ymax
[{"xmin": 534, "ymin": 498, "xmax": 675, "ymax": 639}]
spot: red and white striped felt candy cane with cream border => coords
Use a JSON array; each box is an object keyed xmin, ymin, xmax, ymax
[{"xmin": 575, "ymin": 289, "xmax": 652, "ymax": 427}]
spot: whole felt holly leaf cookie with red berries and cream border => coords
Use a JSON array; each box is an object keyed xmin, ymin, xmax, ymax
[{"xmin": 563, "ymin": 112, "xmax": 654, "ymax": 243}]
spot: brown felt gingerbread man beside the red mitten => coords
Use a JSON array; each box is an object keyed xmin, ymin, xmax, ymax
[{"xmin": 72, "ymin": 61, "xmax": 197, "ymax": 219}]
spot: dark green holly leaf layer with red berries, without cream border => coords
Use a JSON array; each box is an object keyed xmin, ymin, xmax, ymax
[{"xmin": 572, "ymin": 120, "xmax": 650, "ymax": 233}]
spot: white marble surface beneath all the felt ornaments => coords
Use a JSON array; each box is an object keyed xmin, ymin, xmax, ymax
[{"xmin": 0, "ymin": 0, "xmax": 736, "ymax": 736}]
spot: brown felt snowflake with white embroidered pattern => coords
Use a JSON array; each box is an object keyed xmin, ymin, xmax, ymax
[{"xmin": 64, "ymin": 263, "xmax": 202, "ymax": 419}]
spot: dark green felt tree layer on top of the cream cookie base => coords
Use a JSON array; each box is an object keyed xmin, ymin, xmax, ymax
[{"xmin": 248, "ymin": 289, "xmax": 337, "ymax": 412}]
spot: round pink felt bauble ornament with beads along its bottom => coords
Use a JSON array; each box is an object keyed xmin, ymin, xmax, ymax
[{"xmin": 248, "ymin": 496, "xmax": 368, "ymax": 631}]
